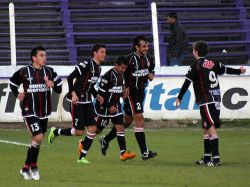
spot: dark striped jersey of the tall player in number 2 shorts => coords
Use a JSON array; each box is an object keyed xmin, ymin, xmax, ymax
[{"xmin": 124, "ymin": 52, "xmax": 155, "ymax": 89}]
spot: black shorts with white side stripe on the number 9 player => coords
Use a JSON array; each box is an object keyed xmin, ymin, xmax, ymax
[{"xmin": 200, "ymin": 103, "xmax": 221, "ymax": 130}]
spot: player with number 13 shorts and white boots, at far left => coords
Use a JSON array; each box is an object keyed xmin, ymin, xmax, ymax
[{"xmin": 10, "ymin": 46, "xmax": 63, "ymax": 180}]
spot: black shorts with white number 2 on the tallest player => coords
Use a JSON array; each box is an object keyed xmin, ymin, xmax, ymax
[{"xmin": 123, "ymin": 89, "xmax": 145, "ymax": 115}]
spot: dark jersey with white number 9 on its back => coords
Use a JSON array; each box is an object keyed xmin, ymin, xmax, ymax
[{"xmin": 178, "ymin": 58, "xmax": 241, "ymax": 105}]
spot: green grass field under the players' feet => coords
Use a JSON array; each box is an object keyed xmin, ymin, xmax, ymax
[{"xmin": 0, "ymin": 123, "xmax": 250, "ymax": 187}]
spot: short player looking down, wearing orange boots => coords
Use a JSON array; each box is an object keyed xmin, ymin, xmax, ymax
[{"xmin": 95, "ymin": 57, "xmax": 136, "ymax": 161}]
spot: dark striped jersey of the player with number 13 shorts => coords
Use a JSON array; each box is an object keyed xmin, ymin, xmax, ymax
[{"xmin": 10, "ymin": 64, "xmax": 63, "ymax": 119}]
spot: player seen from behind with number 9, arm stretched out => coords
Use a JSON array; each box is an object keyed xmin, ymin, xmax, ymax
[{"xmin": 176, "ymin": 41, "xmax": 246, "ymax": 166}]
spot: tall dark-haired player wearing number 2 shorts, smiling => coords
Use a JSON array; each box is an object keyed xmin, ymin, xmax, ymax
[{"xmin": 100, "ymin": 35, "xmax": 157, "ymax": 160}]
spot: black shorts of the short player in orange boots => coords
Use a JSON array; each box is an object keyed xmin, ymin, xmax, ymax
[{"xmin": 96, "ymin": 115, "xmax": 124, "ymax": 131}]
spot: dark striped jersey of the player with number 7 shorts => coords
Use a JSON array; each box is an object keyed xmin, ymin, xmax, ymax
[{"xmin": 67, "ymin": 59, "xmax": 101, "ymax": 104}]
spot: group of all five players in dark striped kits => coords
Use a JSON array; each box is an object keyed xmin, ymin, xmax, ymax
[{"xmin": 10, "ymin": 35, "xmax": 246, "ymax": 180}]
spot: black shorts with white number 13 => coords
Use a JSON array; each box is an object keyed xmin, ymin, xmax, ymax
[{"xmin": 24, "ymin": 116, "xmax": 48, "ymax": 137}]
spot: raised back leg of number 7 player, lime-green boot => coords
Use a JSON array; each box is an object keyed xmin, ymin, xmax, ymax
[{"xmin": 48, "ymin": 104, "xmax": 84, "ymax": 144}]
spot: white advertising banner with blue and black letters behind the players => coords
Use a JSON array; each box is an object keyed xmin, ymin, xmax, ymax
[{"xmin": 0, "ymin": 75, "xmax": 250, "ymax": 122}]
